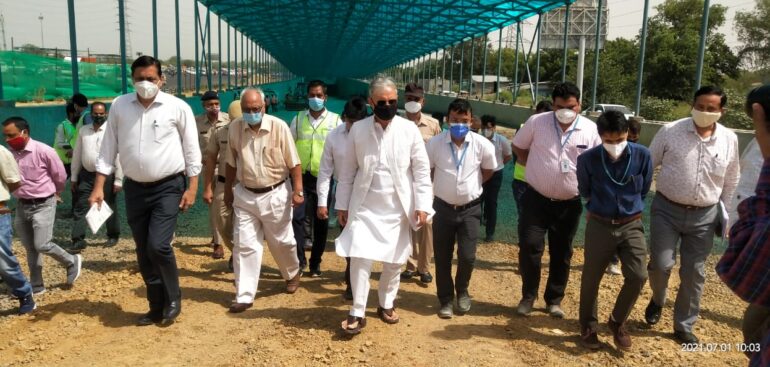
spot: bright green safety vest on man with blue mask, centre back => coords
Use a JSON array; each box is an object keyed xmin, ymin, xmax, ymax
[{"xmin": 294, "ymin": 109, "xmax": 340, "ymax": 177}]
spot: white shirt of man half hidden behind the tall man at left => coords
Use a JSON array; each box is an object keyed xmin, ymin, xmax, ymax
[{"xmin": 70, "ymin": 121, "xmax": 123, "ymax": 186}]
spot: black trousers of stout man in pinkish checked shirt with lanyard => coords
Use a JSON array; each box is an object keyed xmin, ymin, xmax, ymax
[{"xmin": 519, "ymin": 187, "xmax": 583, "ymax": 305}]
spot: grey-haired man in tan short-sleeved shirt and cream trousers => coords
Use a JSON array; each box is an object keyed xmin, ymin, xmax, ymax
[{"xmin": 224, "ymin": 89, "xmax": 304, "ymax": 313}]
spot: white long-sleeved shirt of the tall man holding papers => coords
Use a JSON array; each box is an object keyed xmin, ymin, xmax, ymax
[{"xmin": 96, "ymin": 92, "xmax": 203, "ymax": 182}]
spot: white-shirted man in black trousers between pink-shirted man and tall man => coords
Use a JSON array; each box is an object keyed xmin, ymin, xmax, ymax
[{"xmin": 70, "ymin": 102, "xmax": 123, "ymax": 250}]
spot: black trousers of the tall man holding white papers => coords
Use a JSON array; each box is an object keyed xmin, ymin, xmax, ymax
[{"xmin": 124, "ymin": 174, "xmax": 186, "ymax": 310}]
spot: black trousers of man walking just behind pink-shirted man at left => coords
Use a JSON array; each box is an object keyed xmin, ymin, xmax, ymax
[{"xmin": 72, "ymin": 169, "xmax": 120, "ymax": 242}]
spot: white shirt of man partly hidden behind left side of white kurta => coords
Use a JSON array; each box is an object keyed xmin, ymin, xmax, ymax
[{"xmin": 316, "ymin": 123, "xmax": 355, "ymax": 207}]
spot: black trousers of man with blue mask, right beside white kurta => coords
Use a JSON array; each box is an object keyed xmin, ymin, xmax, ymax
[{"xmin": 433, "ymin": 198, "xmax": 481, "ymax": 305}]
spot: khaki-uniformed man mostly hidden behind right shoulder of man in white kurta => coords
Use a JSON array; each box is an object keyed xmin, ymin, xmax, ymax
[{"xmin": 401, "ymin": 83, "xmax": 441, "ymax": 284}]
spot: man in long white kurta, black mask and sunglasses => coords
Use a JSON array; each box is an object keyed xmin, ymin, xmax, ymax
[{"xmin": 335, "ymin": 77, "xmax": 433, "ymax": 334}]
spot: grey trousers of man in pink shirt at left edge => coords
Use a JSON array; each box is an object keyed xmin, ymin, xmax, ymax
[{"xmin": 15, "ymin": 196, "xmax": 75, "ymax": 288}]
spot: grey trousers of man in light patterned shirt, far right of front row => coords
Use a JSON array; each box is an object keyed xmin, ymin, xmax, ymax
[{"xmin": 648, "ymin": 195, "xmax": 718, "ymax": 332}]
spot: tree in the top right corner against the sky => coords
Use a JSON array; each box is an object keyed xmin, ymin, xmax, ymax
[{"xmin": 735, "ymin": 0, "xmax": 770, "ymax": 70}]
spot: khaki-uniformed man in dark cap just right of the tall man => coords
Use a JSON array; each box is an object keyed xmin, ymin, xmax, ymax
[{"xmin": 195, "ymin": 90, "xmax": 230, "ymax": 259}]
